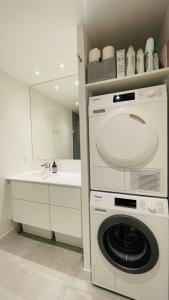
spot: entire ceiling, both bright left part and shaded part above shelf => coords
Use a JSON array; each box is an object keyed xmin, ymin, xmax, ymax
[{"xmin": 0, "ymin": 0, "xmax": 168, "ymax": 85}]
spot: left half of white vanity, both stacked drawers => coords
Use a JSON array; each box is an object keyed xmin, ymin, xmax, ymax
[{"xmin": 12, "ymin": 181, "xmax": 50, "ymax": 230}]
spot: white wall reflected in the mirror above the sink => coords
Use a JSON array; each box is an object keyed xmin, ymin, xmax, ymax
[{"xmin": 30, "ymin": 88, "xmax": 73, "ymax": 160}]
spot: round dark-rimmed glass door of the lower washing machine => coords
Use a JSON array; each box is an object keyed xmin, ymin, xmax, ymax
[{"xmin": 98, "ymin": 215, "xmax": 159, "ymax": 274}]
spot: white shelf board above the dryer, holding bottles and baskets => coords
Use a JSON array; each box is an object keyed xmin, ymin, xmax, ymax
[{"xmin": 86, "ymin": 68, "xmax": 169, "ymax": 96}]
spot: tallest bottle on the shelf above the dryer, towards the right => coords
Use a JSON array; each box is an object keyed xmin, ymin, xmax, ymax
[{"xmin": 145, "ymin": 38, "xmax": 154, "ymax": 72}]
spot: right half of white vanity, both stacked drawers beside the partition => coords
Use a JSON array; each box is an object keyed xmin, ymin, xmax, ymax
[{"xmin": 49, "ymin": 185, "xmax": 82, "ymax": 238}]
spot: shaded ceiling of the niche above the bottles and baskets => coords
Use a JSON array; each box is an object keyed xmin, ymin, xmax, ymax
[{"xmin": 85, "ymin": 0, "xmax": 169, "ymax": 49}]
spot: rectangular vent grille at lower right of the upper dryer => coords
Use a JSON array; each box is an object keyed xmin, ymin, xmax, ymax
[{"xmin": 130, "ymin": 170, "xmax": 161, "ymax": 192}]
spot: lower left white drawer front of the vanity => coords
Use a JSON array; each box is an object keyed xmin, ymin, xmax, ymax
[{"xmin": 12, "ymin": 199, "xmax": 50, "ymax": 230}]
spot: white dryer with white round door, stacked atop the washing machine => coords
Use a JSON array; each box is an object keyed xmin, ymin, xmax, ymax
[{"xmin": 89, "ymin": 85, "xmax": 167, "ymax": 197}]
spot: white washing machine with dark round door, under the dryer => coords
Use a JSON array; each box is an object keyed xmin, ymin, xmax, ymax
[{"xmin": 90, "ymin": 191, "xmax": 168, "ymax": 300}]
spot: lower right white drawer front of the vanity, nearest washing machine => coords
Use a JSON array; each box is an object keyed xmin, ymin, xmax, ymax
[{"xmin": 50, "ymin": 205, "xmax": 82, "ymax": 238}]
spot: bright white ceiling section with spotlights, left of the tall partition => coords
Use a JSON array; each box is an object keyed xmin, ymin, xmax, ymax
[{"xmin": 0, "ymin": 0, "xmax": 82, "ymax": 84}]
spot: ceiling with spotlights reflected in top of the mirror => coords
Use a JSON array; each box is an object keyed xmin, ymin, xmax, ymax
[{"xmin": 30, "ymin": 75, "xmax": 79, "ymax": 112}]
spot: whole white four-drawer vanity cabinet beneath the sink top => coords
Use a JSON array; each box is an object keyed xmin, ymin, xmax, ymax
[{"xmin": 11, "ymin": 180, "xmax": 82, "ymax": 239}]
